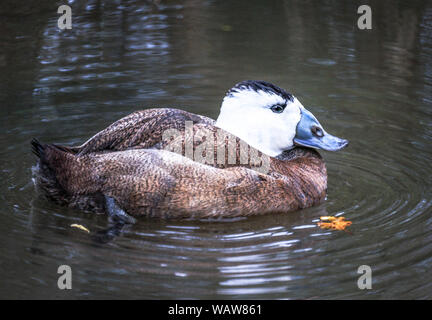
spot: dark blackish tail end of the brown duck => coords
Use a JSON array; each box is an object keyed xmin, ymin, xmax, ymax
[{"xmin": 31, "ymin": 139, "xmax": 74, "ymax": 205}]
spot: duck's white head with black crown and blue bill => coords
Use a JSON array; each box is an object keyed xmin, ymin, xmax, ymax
[{"xmin": 216, "ymin": 80, "xmax": 348, "ymax": 157}]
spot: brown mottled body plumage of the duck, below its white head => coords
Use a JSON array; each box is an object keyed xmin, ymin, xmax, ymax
[{"xmin": 32, "ymin": 109, "xmax": 327, "ymax": 218}]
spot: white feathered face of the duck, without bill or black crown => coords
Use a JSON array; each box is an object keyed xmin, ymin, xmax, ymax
[{"xmin": 216, "ymin": 87, "xmax": 303, "ymax": 157}]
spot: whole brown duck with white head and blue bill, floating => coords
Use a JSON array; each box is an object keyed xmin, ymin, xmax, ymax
[{"xmin": 31, "ymin": 80, "xmax": 348, "ymax": 223}]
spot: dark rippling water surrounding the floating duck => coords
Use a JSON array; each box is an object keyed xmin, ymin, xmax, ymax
[{"xmin": 0, "ymin": 0, "xmax": 432, "ymax": 299}]
